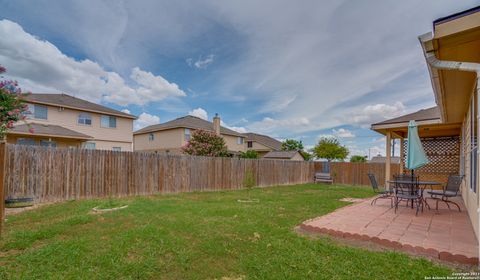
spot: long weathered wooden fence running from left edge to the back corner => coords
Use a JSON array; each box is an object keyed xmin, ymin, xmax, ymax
[{"xmin": 5, "ymin": 145, "xmax": 315, "ymax": 202}]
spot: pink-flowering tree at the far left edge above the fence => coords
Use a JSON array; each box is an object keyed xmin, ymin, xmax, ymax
[{"xmin": 0, "ymin": 65, "xmax": 33, "ymax": 140}]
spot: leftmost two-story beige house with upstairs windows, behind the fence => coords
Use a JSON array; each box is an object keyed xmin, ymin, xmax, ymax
[{"xmin": 7, "ymin": 93, "xmax": 136, "ymax": 151}]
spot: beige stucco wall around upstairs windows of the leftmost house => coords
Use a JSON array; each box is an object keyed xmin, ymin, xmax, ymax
[{"xmin": 13, "ymin": 103, "xmax": 133, "ymax": 151}]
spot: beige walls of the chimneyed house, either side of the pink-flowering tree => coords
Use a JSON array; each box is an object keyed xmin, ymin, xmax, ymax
[{"xmin": 133, "ymin": 128, "xmax": 247, "ymax": 154}]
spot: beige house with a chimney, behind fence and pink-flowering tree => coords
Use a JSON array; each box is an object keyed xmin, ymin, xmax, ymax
[{"xmin": 133, "ymin": 115, "xmax": 246, "ymax": 154}]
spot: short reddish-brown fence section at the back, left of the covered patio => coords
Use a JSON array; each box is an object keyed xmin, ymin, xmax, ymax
[{"xmin": 315, "ymin": 162, "xmax": 400, "ymax": 185}]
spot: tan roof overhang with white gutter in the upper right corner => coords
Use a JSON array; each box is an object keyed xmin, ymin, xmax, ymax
[{"xmin": 419, "ymin": 7, "xmax": 480, "ymax": 123}]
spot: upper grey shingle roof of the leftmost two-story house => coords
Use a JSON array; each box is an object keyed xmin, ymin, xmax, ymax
[{"xmin": 25, "ymin": 93, "xmax": 137, "ymax": 119}]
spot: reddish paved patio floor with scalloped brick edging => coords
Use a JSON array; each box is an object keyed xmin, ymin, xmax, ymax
[{"xmin": 300, "ymin": 195, "xmax": 478, "ymax": 264}]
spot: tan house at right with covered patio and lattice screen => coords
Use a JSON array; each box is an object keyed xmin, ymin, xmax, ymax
[{"xmin": 372, "ymin": 6, "xmax": 480, "ymax": 238}]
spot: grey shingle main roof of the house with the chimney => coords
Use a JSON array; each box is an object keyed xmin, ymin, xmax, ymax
[{"xmin": 133, "ymin": 115, "xmax": 245, "ymax": 137}]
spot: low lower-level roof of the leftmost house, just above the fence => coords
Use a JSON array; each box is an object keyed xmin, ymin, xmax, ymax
[{"xmin": 8, "ymin": 123, "xmax": 93, "ymax": 140}]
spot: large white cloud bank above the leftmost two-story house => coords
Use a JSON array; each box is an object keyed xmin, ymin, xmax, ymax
[{"xmin": 0, "ymin": 20, "xmax": 186, "ymax": 106}]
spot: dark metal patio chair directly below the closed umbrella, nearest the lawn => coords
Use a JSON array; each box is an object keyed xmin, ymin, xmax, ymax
[{"xmin": 394, "ymin": 175, "xmax": 423, "ymax": 215}]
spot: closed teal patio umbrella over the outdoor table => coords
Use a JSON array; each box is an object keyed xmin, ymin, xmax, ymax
[{"xmin": 405, "ymin": 121, "xmax": 428, "ymax": 176}]
